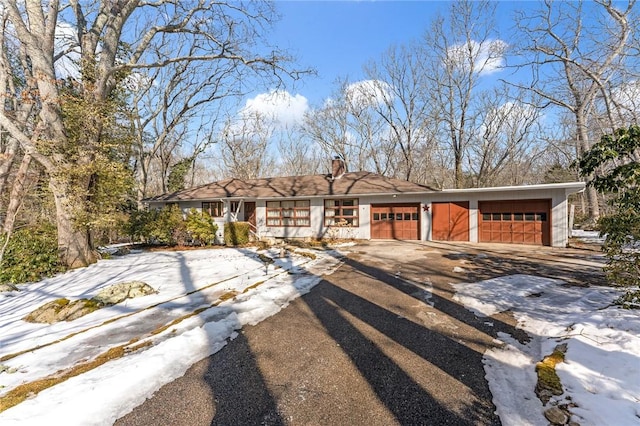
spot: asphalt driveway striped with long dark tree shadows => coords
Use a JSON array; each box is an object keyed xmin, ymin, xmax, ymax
[{"xmin": 116, "ymin": 241, "xmax": 601, "ymax": 426}]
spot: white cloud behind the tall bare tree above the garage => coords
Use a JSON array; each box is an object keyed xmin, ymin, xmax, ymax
[{"xmin": 445, "ymin": 40, "xmax": 507, "ymax": 75}]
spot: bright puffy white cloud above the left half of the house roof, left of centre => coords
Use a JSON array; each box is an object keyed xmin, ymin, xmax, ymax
[{"xmin": 240, "ymin": 90, "xmax": 309, "ymax": 128}]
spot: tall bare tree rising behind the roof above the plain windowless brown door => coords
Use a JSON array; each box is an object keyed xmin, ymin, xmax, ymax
[{"xmin": 424, "ymin": 0, "xmax": 506, "ymax": 188}]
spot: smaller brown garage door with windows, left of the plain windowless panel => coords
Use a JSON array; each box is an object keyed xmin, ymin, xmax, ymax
[{"xmin": 371, "ymin": 204, "xmax": 420, "ymax": 240}]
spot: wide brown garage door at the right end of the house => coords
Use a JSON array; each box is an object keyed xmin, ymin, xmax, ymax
[{"xmin": 478, "ymin": 200, "xmax": 551, "ymax": 246}]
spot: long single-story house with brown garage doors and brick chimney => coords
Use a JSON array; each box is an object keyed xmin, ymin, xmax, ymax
[{"xmin": 145, "ymin": 159, "xmax": 585, "ymax": 247}]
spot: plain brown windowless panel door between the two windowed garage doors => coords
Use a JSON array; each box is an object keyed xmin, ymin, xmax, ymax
[{"xmin": 431, "ymin": 201, "xmax": 469, "ymax": 241}]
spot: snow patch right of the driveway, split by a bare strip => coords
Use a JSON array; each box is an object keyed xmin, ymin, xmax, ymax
[{"xmin": 454, "ymin": 275, "xmax": 640, "ymax": 426}]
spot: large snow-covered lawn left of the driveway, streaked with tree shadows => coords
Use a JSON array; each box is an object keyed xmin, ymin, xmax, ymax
[{"xmin": 0, "ymin": 249, "xmax": 341, "ymax": 426}]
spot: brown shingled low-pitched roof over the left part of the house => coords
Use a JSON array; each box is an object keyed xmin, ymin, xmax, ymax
[{"xmin": 144, "ymin": 172, "xmax": 437, "ymax": 202}]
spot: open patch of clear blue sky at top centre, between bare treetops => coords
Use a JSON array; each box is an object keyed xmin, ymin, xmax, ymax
[{"xmin": 272, "ymin": 1, "xmax": 448, "ymax": 104}]
